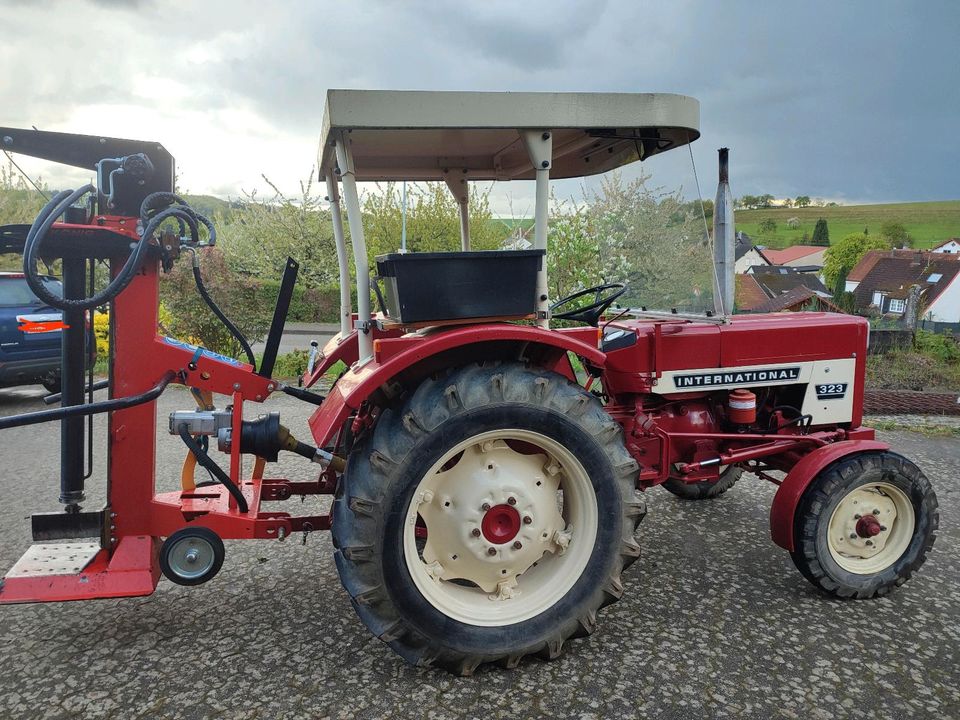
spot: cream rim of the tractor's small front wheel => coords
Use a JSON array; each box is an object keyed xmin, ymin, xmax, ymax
[{"xmin": 827, "ymin": 482, "xmax": 916, "ymax": 575}]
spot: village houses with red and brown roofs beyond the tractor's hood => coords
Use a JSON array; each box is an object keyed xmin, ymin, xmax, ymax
[{"xmin": 736, "ymin": 232, "xmax": 960, "ymax": 333}]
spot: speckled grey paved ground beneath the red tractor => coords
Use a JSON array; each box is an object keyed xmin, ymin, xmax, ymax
[{"xmin": 0, "ymin": 389, "xmax": 960, "ymax": 720}]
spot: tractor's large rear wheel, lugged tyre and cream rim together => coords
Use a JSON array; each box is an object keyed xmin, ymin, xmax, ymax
[{"xmin": 332, "ymin": 363, "xmax": 643, "ymax": 675}]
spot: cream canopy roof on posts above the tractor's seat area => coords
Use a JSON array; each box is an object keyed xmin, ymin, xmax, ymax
[{"xmin": 320, "ymin": 90, "xmax": 700, "ymax": 181}]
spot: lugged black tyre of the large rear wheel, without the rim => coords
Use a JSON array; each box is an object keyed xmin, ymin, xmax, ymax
[{"xmin": 332, "ymin": 363, "xmax": 645, "ymax": 675}]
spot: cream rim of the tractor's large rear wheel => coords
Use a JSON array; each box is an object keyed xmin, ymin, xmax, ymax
[{"xmin": 403, "ymin": 429, "xmax": 598, "ymax": 626}]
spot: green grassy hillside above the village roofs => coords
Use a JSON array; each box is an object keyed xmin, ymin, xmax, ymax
[{"xmin": 736, "ymin": 200, "xmax": 960, "ymax": 248}]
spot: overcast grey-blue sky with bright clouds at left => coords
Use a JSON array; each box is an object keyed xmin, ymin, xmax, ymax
[{"xmin": 0, "ymin": 0, "xmax": 960, "ymax": 214}]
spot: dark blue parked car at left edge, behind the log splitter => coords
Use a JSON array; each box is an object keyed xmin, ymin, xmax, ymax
[{"xmin": 0, "ymin": 272, "xmax": 63, "ymax": 392}]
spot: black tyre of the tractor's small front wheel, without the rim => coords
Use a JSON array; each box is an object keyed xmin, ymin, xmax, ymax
[{"xmin": 790, "ymin": 452, "xmax": 940, "ymax": 599}]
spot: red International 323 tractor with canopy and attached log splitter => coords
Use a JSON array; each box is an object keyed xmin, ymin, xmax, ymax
[{"xmin": 0, "ymin": 91, "xmax": 938, "ymax": 674}]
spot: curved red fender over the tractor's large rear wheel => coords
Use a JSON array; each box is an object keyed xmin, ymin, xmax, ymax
[{"xmin": 309, "ymin": 323, "xmax": 607, "ymax": 447}]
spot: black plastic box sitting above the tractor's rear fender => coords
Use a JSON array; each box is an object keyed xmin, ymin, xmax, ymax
[{"xmin": 377, "ymin": 250, "xmax": 545, "ymax": 323}]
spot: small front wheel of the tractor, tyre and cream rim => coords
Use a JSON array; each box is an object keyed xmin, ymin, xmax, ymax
[{"xmin": 791, "ymin": 452, "xmax": 940, "ymax": 599}]
